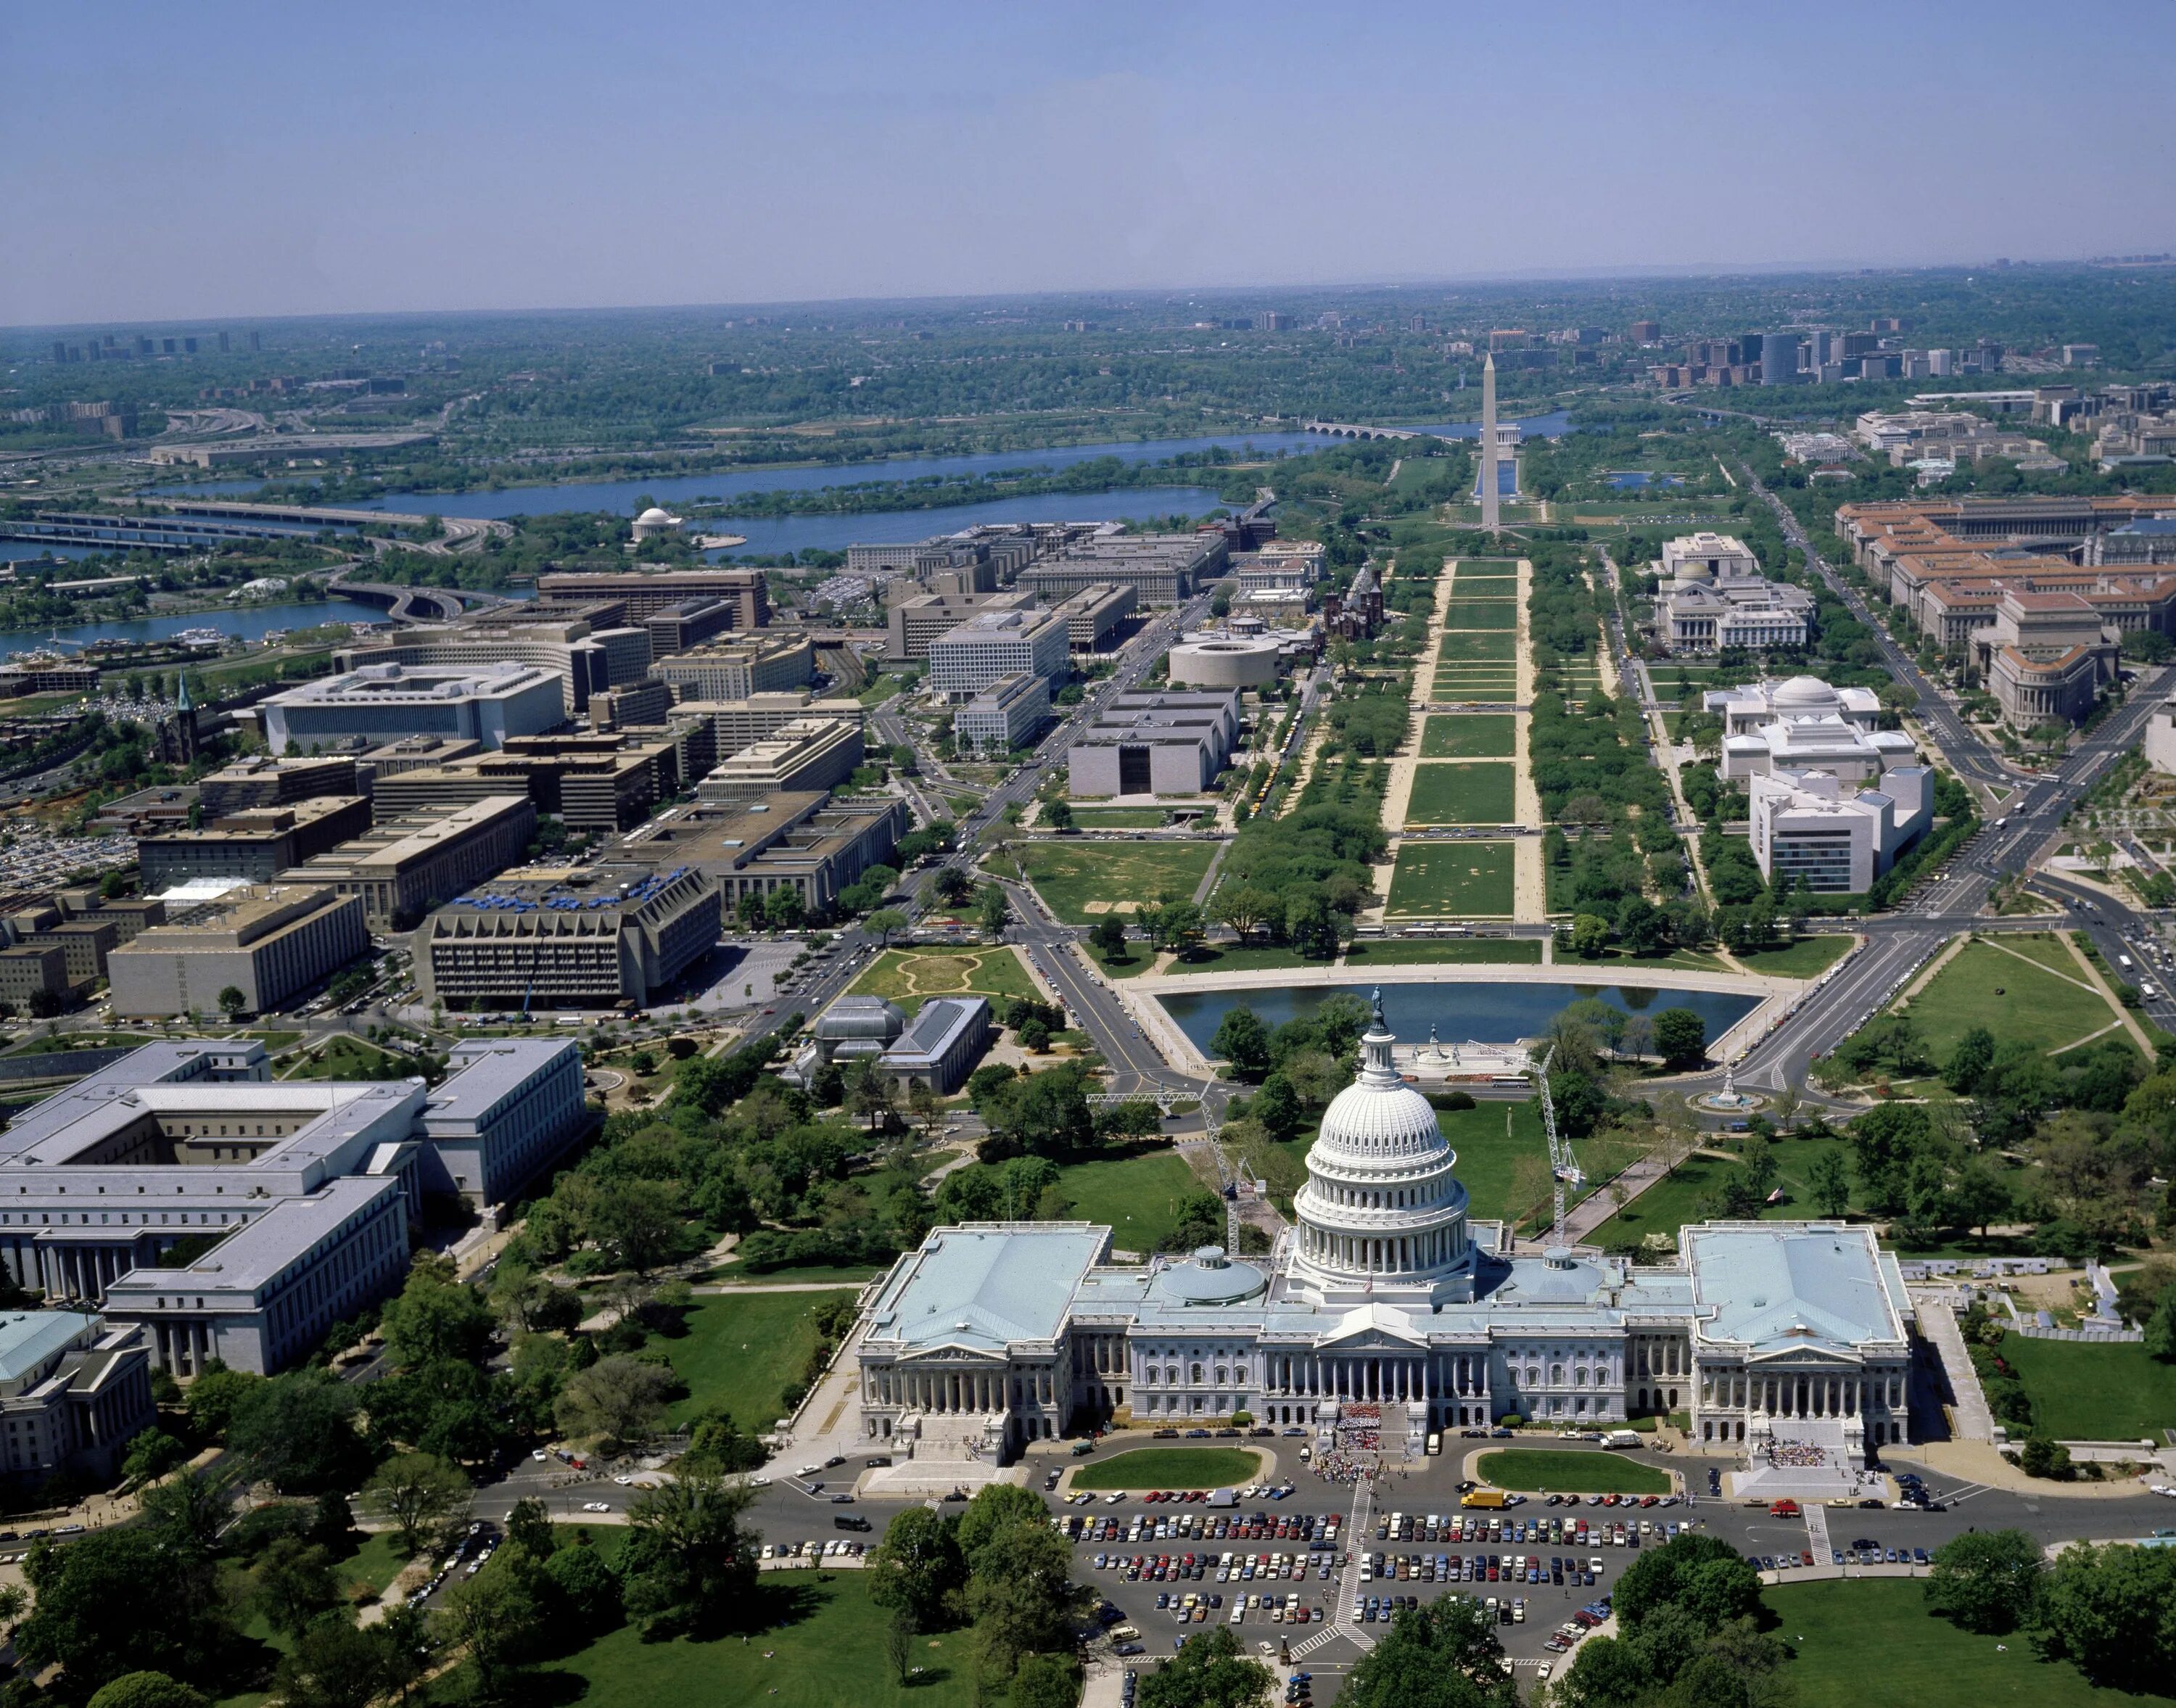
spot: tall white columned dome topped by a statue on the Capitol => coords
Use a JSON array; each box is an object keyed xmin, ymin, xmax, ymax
[{"xmin": 1293, "ymin": 992, "xmax": 1473, "ymax": 1301}]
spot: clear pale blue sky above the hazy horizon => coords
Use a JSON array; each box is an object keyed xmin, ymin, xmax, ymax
[{"xmin": 0, "ymin": 0, "xmax": 2176, "ymax": 324}]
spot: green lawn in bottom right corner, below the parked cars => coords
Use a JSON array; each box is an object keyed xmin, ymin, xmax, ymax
[{"xmin": 1763, "ymin": 1575, "xmax": 2167, "ymax": 1708}]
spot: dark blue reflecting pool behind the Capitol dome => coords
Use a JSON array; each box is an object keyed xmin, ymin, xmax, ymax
[{"xmin": 1158, "ymin": 983, "xmax": 1760, "ymax": 1055}]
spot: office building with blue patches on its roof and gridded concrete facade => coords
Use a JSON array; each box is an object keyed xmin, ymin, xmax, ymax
[{"xmin": 416, "ymin": 864, "xmax": 720, "ymax": 1012}]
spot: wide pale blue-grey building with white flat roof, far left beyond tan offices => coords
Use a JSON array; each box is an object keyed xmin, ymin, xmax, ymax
[{"xmin": 259, "ymin": 661, "xmax": 566, "ymax": 753}]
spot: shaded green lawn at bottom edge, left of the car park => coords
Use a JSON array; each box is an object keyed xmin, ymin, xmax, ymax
[{"xmin": 507, "ymin": 1558, "xmax": 975, "ymax": 1708}]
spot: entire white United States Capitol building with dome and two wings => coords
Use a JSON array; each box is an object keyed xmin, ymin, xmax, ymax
[{"xmin": 855, "ymin": 1005, "xmax": 1913, "ymax": 1480}]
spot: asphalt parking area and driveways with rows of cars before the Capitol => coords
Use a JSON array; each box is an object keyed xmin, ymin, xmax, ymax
[{"xmin": 635, "ymin": 1434, "xmax": 2176, "ymax": 1704}]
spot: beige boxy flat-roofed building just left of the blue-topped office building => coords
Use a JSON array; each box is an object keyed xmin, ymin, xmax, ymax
[{"xmin": 107, "ymin": 886, "xmax": 370, "ymax": 1018}]
